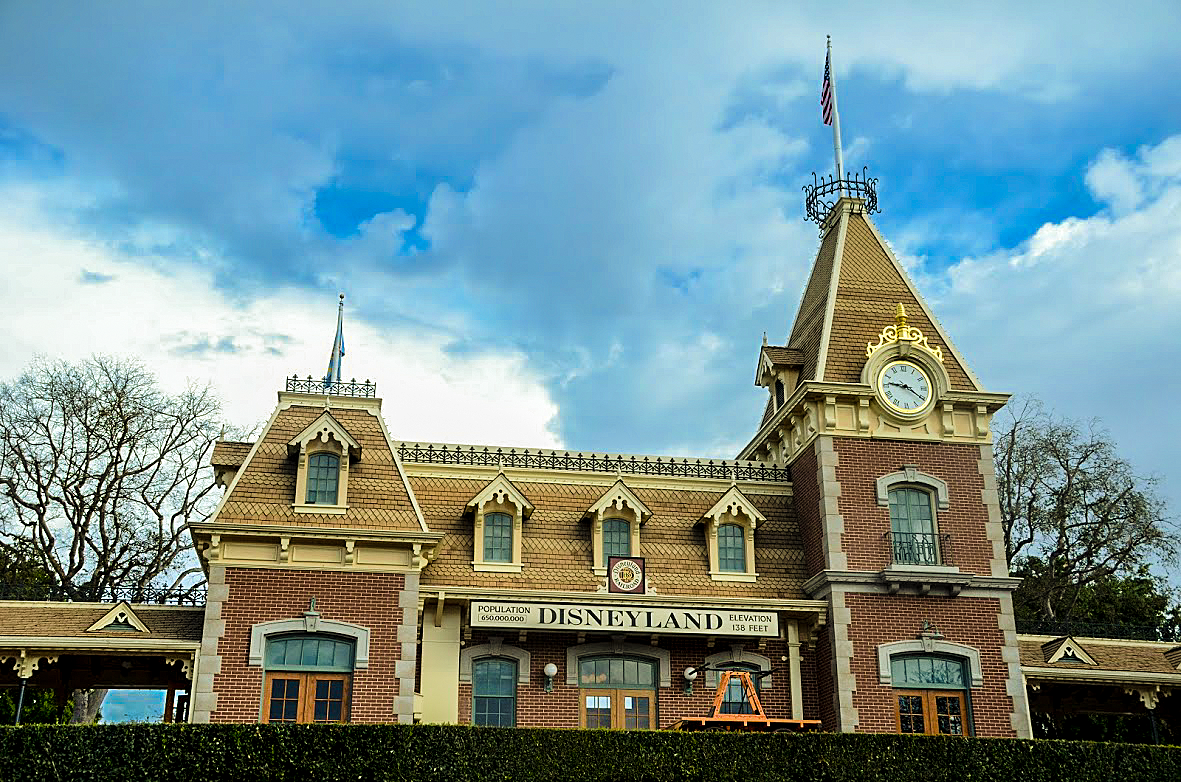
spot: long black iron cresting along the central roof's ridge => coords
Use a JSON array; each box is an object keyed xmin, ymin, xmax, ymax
[{"xmin": 398, "ymin": 443, "xmax": 791, "ymax": 482}]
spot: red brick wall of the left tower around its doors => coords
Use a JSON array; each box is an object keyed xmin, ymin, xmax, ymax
[{"xmin": 210, "ymin": 568, "xmax": 405, "ymax": 722}]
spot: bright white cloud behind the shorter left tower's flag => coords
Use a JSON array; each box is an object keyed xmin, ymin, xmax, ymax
[{"xmin": 0, "ymin": 188, "xmax": 561, "ymax": 448}]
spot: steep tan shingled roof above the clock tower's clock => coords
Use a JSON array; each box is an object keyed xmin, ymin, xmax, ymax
[{"xmin": 788, "ymin": 198, "xmax": 983, "ymax": 391}]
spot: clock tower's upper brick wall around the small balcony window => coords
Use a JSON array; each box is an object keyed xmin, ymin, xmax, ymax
[{"xmin": 831, "ymin": 438, "xmax": 992, "ymax": 575}]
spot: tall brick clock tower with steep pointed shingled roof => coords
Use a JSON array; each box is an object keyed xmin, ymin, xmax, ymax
[{"xmin": 738, "ymin": 176, "xmax": 1030, "ymax": 736}]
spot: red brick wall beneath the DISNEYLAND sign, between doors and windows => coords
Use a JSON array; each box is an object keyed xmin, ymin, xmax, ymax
[{"xmin": 451, "ymin": 633, "xmax": 820, "ymax": 728}]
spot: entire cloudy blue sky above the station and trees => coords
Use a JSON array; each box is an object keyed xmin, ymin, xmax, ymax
[{"xmin": 0, "ymin": 1, "xmax": 1181, "ymax": 548}]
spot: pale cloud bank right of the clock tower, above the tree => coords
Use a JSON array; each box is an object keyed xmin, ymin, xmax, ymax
[{"xmin": 925, "ymin": 136, "xmax": 1181, "ymax": 513}]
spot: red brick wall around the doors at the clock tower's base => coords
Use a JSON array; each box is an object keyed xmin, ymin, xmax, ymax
[{"xmin": 844, "ymin": 593, "xmax": 1016, "ymax": 736}]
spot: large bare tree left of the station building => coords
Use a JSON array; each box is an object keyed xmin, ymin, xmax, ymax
[{"xmin": 0, "ymin": 357, "xmax": 220, "ymax": 600}]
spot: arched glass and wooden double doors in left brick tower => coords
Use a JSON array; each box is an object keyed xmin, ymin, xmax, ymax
[{"xmin": 262, "ymin": 634, "xmax": 355, "ymax": 722}]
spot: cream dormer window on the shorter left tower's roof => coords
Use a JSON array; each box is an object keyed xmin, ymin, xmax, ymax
[{"xmin": 287, "ymin": 410, "xmax": 361, "ymax": 516}]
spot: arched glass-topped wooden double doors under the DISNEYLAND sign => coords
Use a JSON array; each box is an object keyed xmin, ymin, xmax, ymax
[{"xmin": 579, "ymin": 656, "xmax": 657, "ymax": 730}]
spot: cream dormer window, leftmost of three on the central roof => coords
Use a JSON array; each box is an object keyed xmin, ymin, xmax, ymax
[{"xmin": 468, "ymin": 473, "xmax": 533, "ymax": 573}]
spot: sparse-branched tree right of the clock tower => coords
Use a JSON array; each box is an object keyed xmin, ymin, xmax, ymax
[{"xmin": 993, "ymin": 400, "xmax": 1179, "ymax": 619}]
